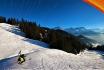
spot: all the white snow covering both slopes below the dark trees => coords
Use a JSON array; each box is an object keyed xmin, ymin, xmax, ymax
[{"xmin": 0, "ymin": 23, "xmax": 104, "ymax": 70}]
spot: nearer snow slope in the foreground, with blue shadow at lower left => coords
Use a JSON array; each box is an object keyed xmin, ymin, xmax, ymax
[{"xmin": 0, "ymin": 49, "xmax": 104, "ymax": 70}]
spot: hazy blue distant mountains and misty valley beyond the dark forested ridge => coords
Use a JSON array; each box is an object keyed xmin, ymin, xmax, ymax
[{"xmin": 64, "ymin": 27, "xmax": 104, "ymax": 44}]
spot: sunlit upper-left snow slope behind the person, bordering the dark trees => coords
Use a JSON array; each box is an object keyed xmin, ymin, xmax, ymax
[{"xmin": 0, "ymin": 23, "xmax": 48, "ymax": 59}]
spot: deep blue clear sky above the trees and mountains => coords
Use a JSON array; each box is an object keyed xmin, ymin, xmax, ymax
[{"xmin": 0, "ymin": 0, "xmax": 104, "ymax": 28}]
